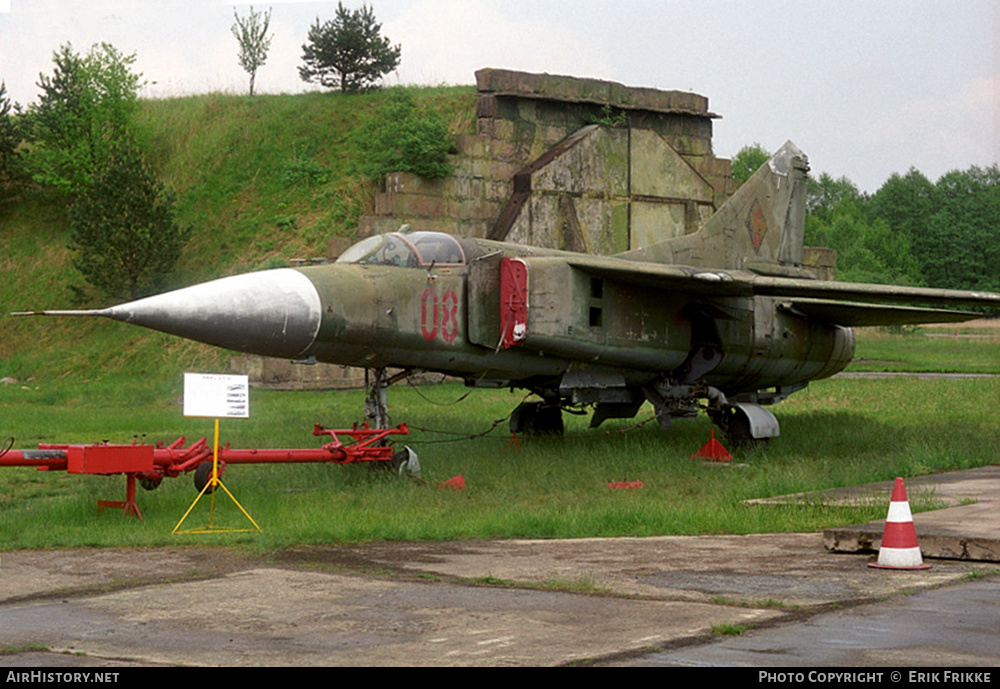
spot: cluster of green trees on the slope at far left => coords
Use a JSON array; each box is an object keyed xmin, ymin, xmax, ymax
[{"xmin": 0, "ymin": 43, "xmax": 190, "ymax": 299}]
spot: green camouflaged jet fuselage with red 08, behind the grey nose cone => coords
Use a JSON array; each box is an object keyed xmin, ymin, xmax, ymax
[{"xmin": 300, "ymin": 233, "xmax": 853, "ymax": 404}]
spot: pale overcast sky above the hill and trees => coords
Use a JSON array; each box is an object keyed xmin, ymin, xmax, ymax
[{"xmin": 0, "ymin": 0, "xmax": 1000, "ymax": 191}]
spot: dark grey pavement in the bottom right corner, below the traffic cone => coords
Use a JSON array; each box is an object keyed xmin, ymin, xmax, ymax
[{"xmin": 596, "ymin": 581, "xmax": 1000, "ymax": 668}]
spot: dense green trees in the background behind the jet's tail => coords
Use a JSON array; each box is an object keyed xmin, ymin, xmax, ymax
[{"xmin": 733, "ymin": 144, "xmax": 1000, "ymax": 292}]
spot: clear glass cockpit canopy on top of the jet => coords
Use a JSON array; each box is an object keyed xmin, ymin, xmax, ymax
[{"xmin": 337, "ymin": 232, "xmax": 465, "ymax": 268}]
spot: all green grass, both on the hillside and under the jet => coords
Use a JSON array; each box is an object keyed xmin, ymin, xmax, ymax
[{"xmin": 0, "ymin": 87, "xmax": 1000, "ymax": 550}]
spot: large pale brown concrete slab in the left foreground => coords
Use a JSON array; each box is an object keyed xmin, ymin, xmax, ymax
[{"xmin": 0, "ymin": 568, "xmax": 782, "ymax": 666}]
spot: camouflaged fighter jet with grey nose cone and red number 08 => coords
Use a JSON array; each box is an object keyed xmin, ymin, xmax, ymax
[{"xmin": 19, "ymin": 142, "xmax": 1000, "ymax": 444}]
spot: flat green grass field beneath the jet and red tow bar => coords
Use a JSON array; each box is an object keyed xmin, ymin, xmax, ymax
[{"xmin": 0, "ymin": 368, "xmax": 1000, "ymax": 551}]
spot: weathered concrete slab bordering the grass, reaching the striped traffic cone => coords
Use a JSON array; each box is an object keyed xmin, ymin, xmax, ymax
[{"xmin": 276, "ymin": 533, "xmax": 992, "ymax": 612}]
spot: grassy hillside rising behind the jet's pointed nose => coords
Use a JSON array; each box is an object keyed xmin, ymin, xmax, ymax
[{"xmin": 0, "ymin": 86, "xmax": 475, "ymax": 381}]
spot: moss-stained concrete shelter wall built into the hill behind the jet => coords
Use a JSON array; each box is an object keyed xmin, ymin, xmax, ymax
[{"xmin": 360, "ymin": 69, "xmax": 736, "ymax": 254}]
